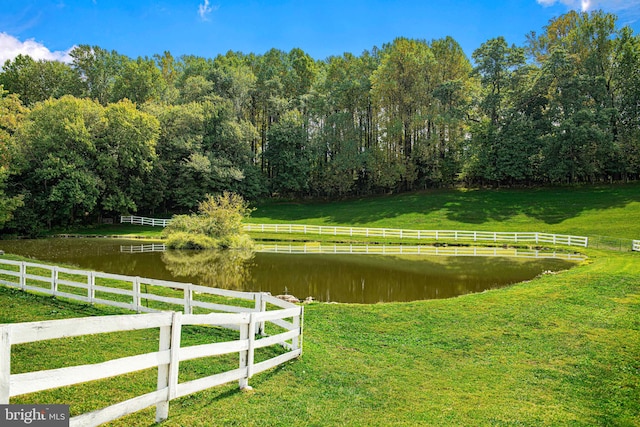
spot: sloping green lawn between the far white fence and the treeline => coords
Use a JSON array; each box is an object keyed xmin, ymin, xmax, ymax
[{"xmin": 250, "ymin": 183, "xmax": 640, "ymax": 239}]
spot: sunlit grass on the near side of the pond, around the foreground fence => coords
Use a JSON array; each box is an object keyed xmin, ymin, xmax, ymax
[{"xmin": 0, "ymin": 252, "xmax": 640, "ymax": 426}]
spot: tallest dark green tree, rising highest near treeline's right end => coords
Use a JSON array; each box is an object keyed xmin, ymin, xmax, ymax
[{"xmin": 529, "ymin": 11, "xmax": 628, "ymax": 182}]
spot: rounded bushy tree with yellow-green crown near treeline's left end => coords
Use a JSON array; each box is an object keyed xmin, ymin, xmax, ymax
[{"xmin": 15, "ymin": 96, "xmax": 104, "ymax": 230}]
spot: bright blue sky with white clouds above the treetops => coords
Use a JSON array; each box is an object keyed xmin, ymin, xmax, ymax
[{"xmin": 0, "ymin": 0, "xmax": 640, "ymax": 64}]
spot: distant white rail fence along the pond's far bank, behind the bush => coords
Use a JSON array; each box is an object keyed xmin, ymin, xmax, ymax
[{"xmin": 120, "ymin": 216, "xmax": 589, "ymax": 248}]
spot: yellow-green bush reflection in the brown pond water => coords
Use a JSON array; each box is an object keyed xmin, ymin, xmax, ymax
[{"xmin": 162, "ymin": 249, "xmax": 254, "ymax": 290}]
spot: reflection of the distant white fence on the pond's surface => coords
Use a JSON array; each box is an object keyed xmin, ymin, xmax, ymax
[{"xmin": 120, "ymin": 243, "xmax": 587, "ymax": 261}]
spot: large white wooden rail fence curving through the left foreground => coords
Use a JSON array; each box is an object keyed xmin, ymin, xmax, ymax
[{"xmin": 0, "ymin": 259, "xmax": 303, "ymax": 426}]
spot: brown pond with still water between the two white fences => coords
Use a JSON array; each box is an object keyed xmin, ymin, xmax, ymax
[{"xmin": 0, "ymin": 238, "xmax": 575, "ymax": 304}]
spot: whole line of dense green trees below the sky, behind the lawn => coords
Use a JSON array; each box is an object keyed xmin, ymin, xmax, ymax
[{"xmin": 0, "ymin": 11, "xmax": 640, "ymax": 233}]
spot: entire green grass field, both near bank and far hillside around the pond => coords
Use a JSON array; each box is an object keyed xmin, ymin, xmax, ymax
[{"xmin": 0, "ymin": 184, "xmax": 640, "ymax": 426}]
